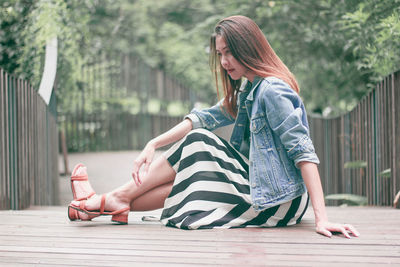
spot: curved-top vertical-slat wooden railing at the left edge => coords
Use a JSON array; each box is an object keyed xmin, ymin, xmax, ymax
[{"xmin": 0, "ymin": 69, "xmax": 59, "ymax": 209}]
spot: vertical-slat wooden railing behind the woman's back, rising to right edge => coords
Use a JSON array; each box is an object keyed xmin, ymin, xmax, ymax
[{"xmin": 309, "ymin": 72, "xmax": 400, "ymax": 206}]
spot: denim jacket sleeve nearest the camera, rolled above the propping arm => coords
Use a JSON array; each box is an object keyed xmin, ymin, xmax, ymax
[{"xmin": 262, "ymin": 79, "xmax": 319, "ymax": 166}]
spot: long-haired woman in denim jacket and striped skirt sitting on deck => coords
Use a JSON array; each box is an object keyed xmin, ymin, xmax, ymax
[{"xmin": 69, "ymin": 16, "xmax": 359, "ymax": 238}]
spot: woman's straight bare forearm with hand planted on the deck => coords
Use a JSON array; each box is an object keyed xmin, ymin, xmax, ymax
[{"xmin": 298, "ymin": 161, "xmax": 360, "ymax": 238}]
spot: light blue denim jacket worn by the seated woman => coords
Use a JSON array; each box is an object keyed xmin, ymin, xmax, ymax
[{"xmin": 186, "ymin": 77, "xmax": 319, "ymax": 211}]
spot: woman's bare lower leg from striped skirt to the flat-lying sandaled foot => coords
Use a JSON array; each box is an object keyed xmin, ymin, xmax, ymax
[{"xmin": 73, "ymin": 156, "xmax": 176, "ymax": 217}]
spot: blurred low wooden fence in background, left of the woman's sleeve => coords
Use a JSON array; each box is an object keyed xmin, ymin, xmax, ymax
[{"xmin": 60, "ymin": 110, "xmax": 182, "ymax": 152}]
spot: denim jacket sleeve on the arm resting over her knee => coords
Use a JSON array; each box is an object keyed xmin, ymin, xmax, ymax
[{"xmin": 185, "ymin": 99, "xmax": 235, "ymax": 131}]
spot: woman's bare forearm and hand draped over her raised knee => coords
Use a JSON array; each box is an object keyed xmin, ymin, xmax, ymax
[{"xmin": 132, "ymin": 119, "xmax": 193, "ymax": 185}]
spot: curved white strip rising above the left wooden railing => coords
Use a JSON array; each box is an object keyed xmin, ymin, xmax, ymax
[{"xmin": 39, "ymin": 37, "xmax": 58, "ymax": 105}]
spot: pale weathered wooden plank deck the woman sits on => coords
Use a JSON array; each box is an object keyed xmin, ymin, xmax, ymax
[{"xmin": 0, "ymin": 207, "xmax": 400, "ymax": 266}]
